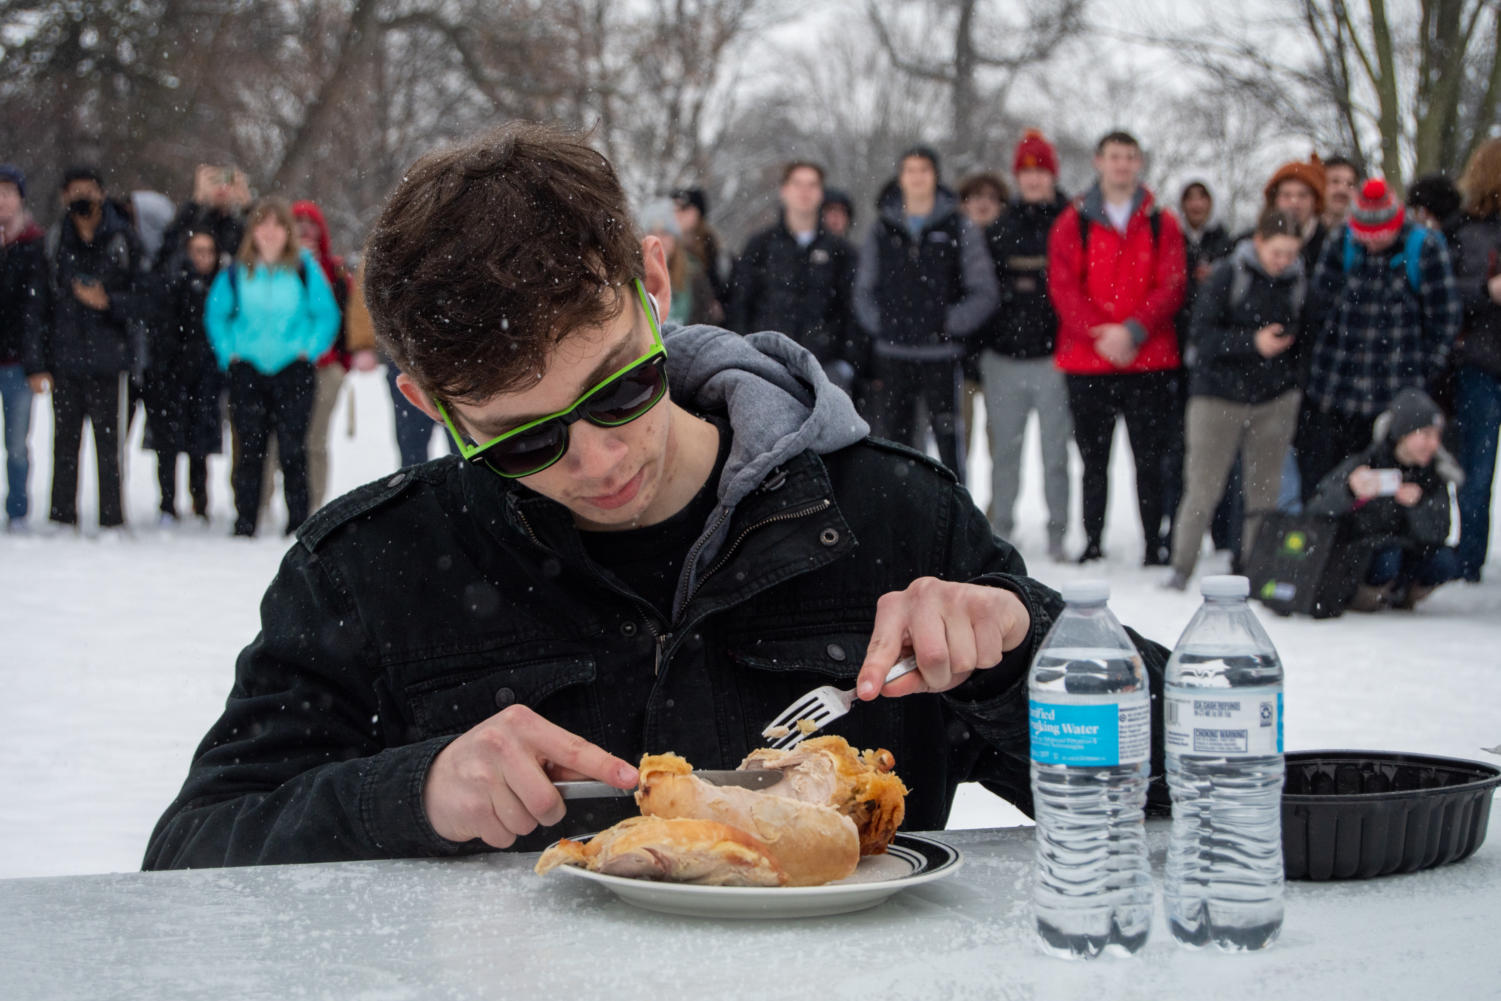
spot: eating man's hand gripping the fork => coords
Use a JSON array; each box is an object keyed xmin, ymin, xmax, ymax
[{"xmin": 856, "ymin": 576, "xmax": 1031, "ymax": 701}]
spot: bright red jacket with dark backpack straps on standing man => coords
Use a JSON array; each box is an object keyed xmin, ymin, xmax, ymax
[{"xmin": 1048, "ymin": 188, "xmax": 1186, "ymax": 375}]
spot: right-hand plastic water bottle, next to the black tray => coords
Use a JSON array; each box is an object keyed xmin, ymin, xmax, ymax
[{"xmin": 1163, "ymin": 576, "xmax": 1283, "ymax": 951}]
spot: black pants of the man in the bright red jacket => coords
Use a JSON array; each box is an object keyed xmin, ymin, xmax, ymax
[{"xmin": 1067, "ymin": 372, "xmax": 1174, "ymax": 563}]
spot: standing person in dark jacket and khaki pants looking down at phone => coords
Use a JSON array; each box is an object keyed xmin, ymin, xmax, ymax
[{"xmin": 1166, "ymin": 209, "xmax": 1307, "ymax": 591}]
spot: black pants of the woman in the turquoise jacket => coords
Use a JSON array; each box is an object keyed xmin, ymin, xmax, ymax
[{"xmin": 230, "ymin": 362, "xmax": 315, "ymax": 536}]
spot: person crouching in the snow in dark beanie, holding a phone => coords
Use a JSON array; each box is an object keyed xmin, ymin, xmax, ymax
[{"xmin": 1306, "ymin": 387, "xmax": 1462, "ymax": 612}]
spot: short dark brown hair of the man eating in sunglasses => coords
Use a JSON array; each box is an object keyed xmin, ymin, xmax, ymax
[{"xmin": 365, "ymin": 122, "xmax": 644, "ymax": 402}]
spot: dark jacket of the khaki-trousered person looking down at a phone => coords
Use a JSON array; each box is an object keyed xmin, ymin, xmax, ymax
[{"xmin": 1189, "ymin": 240, "xmax": 1307, "ymax": 404}]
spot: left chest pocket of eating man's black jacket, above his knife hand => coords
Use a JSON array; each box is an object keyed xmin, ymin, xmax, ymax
[{"xmin": 404, "ymin": 654, "xmax": 602, "ymax": 743}]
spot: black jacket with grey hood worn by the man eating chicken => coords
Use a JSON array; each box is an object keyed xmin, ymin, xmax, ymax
[{"xmin": 146, "ymin": 327, "xmax": 1166, "ymax": 869}]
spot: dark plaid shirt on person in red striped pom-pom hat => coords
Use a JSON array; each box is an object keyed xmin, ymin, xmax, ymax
[{"xmin": 1304, "ymin": 224, "xmax": 1463, "ymax": 417}]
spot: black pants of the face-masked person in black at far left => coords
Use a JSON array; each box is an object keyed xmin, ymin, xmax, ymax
[{"xmin": 51, "ymin": 367, "xmax": 125, "ymax": 528}]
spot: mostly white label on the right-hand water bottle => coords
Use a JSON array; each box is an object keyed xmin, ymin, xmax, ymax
[{"xmin": 1162, "ymin": 687, "xmax": 1282, "ymax": 758}]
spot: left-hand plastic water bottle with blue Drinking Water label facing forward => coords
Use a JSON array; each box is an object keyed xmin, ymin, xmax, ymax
[{"xmin": 1027, "ymin": 581, "xmax": 1153, "ymax": 959}]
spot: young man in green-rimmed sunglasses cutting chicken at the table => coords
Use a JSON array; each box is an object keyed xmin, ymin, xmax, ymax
[{"xmin": 146, "ymin": 125, "xmax": 1166, "ymax": 867}]
